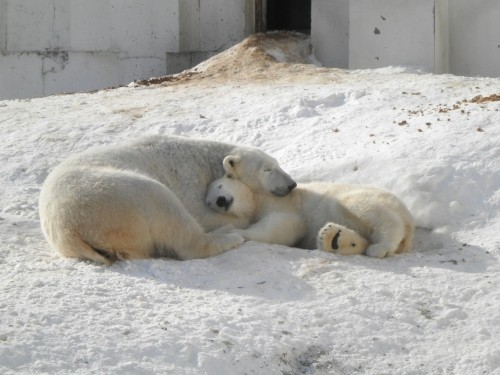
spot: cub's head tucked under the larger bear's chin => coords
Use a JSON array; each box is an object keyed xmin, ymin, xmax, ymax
[{"xmin": 205, "ymin": 177, "xmax": 255, "ymax": 219}]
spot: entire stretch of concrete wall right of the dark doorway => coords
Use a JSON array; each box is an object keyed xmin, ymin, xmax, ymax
[{"xmin": 311, "ymin": 0, "xmax": 500, "ymax": 76}]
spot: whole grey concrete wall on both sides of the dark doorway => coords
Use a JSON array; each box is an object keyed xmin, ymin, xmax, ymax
[{"xmin": 0, "ymin": 0, "xmax": 500, "ymax": 100}]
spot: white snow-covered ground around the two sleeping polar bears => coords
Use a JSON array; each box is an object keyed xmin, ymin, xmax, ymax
[{"xmin": 0, "ymin": 33, "xmax": 500, "ymax": 375}]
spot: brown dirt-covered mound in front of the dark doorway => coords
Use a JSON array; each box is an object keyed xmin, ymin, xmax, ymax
[{"xmin": 136, "ymin": 32, "xmax": 345, "ymax": 85}]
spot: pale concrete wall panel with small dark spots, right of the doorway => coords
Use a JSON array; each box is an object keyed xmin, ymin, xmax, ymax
[{"xmin": 349, "ymin": 0, "xmax": 434, "ymax": 71}]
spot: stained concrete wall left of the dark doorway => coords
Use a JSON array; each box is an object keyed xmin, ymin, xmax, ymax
[{"xmin": 0, "ymin": 0, "xmax": 253, "ymax": 99}]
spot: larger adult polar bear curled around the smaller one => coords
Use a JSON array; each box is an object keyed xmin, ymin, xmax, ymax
[{"xmin": 39, "ymin": 136, "xmax": 296, "ymax": 264}]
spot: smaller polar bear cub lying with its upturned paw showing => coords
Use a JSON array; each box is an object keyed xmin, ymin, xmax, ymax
[{"xmin": 205, "ymin": 177, "xmax": 415, "ymax": 257}]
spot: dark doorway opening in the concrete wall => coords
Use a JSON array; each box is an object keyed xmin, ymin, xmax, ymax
[{"xmin": 266, "ymin": 0, "xmax": 311, "ymax": 34}]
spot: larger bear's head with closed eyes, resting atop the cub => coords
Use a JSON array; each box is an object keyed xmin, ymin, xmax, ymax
[{"xmin": 223, "ymin": 149, "xmax": 297, "ymax": 197}]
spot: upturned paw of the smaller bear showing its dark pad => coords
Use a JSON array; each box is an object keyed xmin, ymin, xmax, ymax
[{"xmin": 317, "ymin": 223, "xmax": 368, "ymax": 255}]
